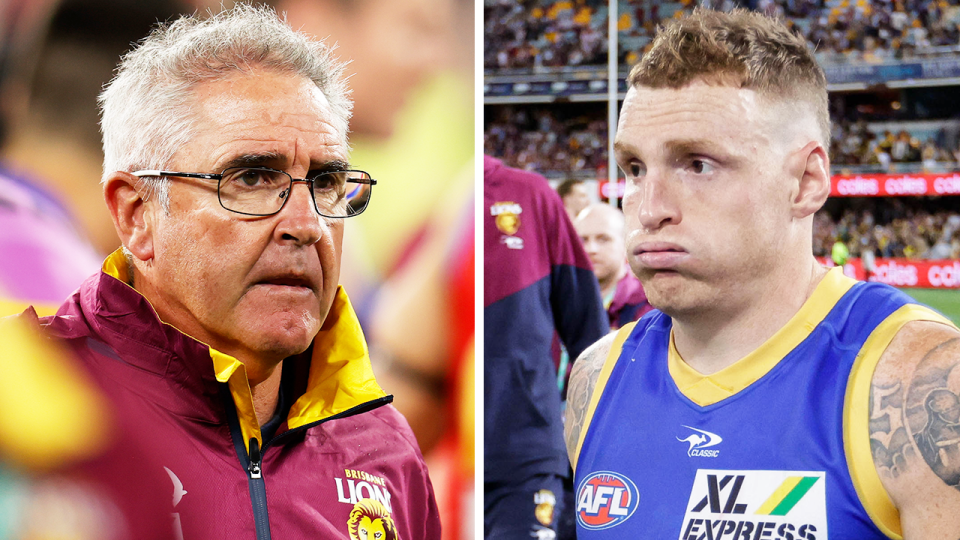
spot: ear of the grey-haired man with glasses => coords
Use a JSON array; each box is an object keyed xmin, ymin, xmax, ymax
[{"xmin": 103, "ymin": 171, "xmax": 154, "ymax": 261}]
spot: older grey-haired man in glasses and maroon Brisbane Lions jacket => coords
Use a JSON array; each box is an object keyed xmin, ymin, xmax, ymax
[{"xmin": 13, "ymin": 5, "xmax": 439, "ymax": 540}]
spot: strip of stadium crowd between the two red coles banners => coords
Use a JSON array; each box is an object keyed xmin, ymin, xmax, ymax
[{"xmin": 813, "ymin": 198, "xmax": 960, "ymax": 259}]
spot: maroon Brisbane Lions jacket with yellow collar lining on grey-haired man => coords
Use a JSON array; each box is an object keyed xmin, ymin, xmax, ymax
[{"xmin": 31, "ymin": 251, "xmax": 440, "ymax": 540}]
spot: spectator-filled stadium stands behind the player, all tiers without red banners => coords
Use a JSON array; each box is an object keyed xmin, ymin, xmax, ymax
[{"xmin": 483, "ymin": 0, "xmax": 960, "ymax": 272}]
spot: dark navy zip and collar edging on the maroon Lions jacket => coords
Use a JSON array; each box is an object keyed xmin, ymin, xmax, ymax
[{"xmin": 220, "ymin": 383, "xmax": 393, "ymax": 540}]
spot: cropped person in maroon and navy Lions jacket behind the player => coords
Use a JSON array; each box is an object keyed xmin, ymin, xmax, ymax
[{"xmin": 483, "ymin": 156, "xmax": 607, "ymax": 539}]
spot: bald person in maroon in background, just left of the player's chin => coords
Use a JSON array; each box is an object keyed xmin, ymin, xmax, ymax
[{"xmin": 573, "ymin": 203, "xmax": 653, "ymax": 330}]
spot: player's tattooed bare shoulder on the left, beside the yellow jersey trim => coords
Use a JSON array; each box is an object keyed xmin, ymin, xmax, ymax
[{"xmin": 563, "ymin": 332, "xmax": 617, "ymax": 463}]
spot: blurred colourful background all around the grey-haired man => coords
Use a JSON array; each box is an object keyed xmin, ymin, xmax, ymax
[{"xmin": 0, "ymin": 0, "xmax": 474, "ymax": 540}]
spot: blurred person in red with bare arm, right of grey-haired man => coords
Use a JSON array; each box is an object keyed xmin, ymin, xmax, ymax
[{"xmin": 369, "ymin": 167, "xmax": 475, "ymax": 540}]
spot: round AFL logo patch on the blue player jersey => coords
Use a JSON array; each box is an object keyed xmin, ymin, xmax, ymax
[{"xmin": 577, "ymin": 471, "xmax": 640, "ymax": 530}]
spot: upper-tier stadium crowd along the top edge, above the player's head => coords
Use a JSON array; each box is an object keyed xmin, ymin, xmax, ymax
[{"xmin": 484, "ymin": 0, "xmax": 960, "ymax": 69}]
